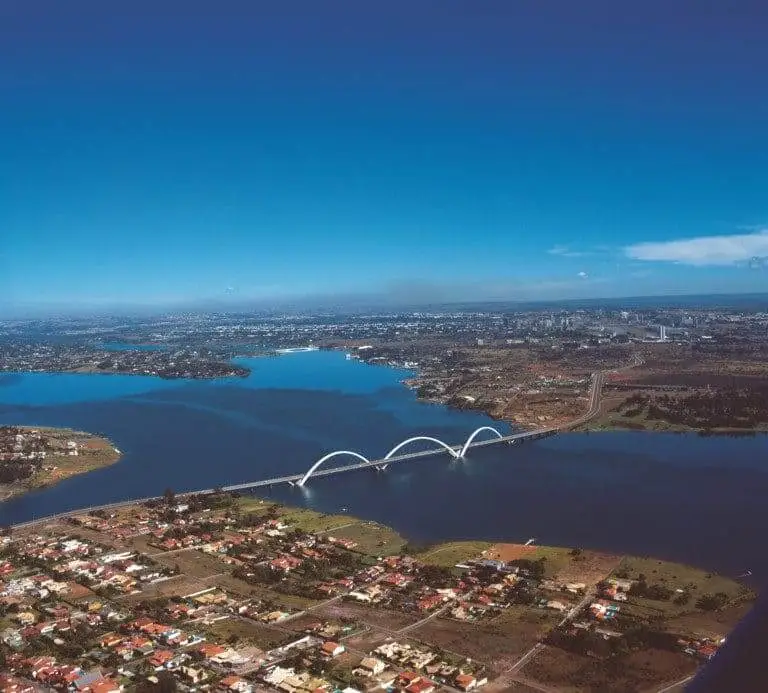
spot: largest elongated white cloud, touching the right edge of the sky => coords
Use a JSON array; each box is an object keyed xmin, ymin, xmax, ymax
[{"xmin": 624, "ymin": 229, "xmax": 768, "ymax": 266}]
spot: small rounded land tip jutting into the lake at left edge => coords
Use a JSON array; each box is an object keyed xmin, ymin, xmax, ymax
[{"xmin": 0, "ymin": 426, "xmax": 120, "ymax": 501}]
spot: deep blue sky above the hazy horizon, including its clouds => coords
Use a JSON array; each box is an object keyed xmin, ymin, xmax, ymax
[{"xmin": 0, "ymin": 0, "xmax": 768, "ymax": 311}]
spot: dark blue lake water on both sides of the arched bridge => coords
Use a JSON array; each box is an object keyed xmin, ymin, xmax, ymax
[{"xmin": 0, "ymin": 352, "xmax": 768, "ymax": 580}]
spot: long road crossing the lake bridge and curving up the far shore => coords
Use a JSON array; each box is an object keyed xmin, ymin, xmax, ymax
[{"xmin": 14, "ymin": 358, "xmax": 642, "ymax": 528}]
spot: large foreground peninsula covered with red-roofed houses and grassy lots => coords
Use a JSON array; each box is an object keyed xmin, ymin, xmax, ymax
[{"xmin": 0, "ymin": 490, "xmax": 754, "ymax": 693}]
